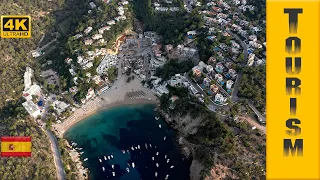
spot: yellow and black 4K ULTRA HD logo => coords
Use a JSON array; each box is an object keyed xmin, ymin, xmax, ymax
[{"xmin": 1, "ymin": 16, "xmax": 31, "ymax": 38}]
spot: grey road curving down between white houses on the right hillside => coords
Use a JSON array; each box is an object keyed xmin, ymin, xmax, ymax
[{"xmin": 228, "ymin": 31, "xmax": 248, "ymax": 102}]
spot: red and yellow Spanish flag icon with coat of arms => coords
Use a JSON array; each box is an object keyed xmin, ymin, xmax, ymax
[{"xmin": 1, "ymin": 136, "xmax": 31, "ymax": 157}]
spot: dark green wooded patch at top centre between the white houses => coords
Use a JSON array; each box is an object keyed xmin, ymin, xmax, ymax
[{"xmin": 133, "ymin": 0, "xmax": 203, "ymax": 45}]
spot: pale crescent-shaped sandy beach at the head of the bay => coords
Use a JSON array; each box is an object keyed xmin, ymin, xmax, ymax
[{"xmin": 53, "ymin": 75, "xmax": 159, "ymax": 137}]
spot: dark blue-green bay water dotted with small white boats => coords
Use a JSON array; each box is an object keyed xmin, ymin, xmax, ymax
[{"xmin": 65, "ymin": 104, "xmax": 191, "ymax": 180}]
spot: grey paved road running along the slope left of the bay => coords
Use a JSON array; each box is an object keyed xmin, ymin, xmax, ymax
[{"xmin": 46, "ymin": 130, "xmax": 66, "ymax": 180}]
